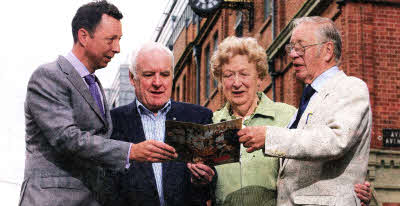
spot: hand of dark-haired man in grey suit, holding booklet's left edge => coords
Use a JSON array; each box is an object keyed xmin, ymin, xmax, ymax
[{"xmin": 129, "ymin": 140, "xmax": 178, "ymax": 162}]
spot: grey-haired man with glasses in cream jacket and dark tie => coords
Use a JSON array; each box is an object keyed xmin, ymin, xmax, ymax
[{"xmin": 238, "ymin": 17, "xmax": 372, "ymax": 206}]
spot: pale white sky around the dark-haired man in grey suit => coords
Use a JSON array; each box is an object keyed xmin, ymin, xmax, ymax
[{"xmin": 0, "ymin": 0, "xmax": 168, "ymax": 205}]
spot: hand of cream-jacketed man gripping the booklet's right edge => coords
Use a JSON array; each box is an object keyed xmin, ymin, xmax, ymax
[{"xmin": 237, "ymin": 126, "xmax": 266, "ymax": 153}]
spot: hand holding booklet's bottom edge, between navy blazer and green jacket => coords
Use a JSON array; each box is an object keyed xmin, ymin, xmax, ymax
[{"xmin": 187, "ymin": 163, "xmax": 215, "ymax": 185}]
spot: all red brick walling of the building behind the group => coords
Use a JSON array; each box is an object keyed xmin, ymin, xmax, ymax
[{"xmin": 170, "ymin": 0, "xmax": 400, "ymax": 148}]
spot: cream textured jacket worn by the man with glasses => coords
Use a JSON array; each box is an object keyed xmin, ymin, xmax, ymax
[{"xmin": 265, "ymin": 71, "xmax": 372, "ymax": 206}]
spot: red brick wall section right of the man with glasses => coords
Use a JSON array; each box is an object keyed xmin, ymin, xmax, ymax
[{"xmin": 336, "ymin": 3, "xmax": 400, "ymax": 148}]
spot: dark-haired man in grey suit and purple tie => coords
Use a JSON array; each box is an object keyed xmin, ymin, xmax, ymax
[{"xmin": 19, "ymin": 1, "xmax": 177, "ymax": 206}]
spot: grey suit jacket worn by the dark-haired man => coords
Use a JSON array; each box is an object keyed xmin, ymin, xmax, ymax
[{"xmin": 20, "ymin": 56, "xmax": 130, "ymax": 206}]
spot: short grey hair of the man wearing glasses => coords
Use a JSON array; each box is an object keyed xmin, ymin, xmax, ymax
[{"xmin": 293, "ymin": 16, "xmax": 342, "ymax": 65}]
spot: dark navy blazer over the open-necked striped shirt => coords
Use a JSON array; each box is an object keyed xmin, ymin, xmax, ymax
[{"xmin": 104, "ymin": 100, "xmax": 216, "ymax": 206}]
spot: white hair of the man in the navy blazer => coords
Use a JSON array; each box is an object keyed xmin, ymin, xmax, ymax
[{"xmin": 129, "ymin": 42, "xmax": 174, "ymax": 79}]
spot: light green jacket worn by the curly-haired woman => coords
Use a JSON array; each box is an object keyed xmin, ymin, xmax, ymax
[{"xmin": 213, "ymin": 92, "xmax": 296, "ymax": 206}]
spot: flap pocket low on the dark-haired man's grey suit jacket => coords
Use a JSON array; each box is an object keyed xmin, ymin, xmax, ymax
[{"xmin": 40, "ymin": 177, "xmax": 85, "ymax": 189}]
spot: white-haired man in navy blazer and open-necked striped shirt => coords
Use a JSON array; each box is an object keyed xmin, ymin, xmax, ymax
[{"xmin": 110, "ymin": 43, "xmax": 215, "ymax": 206}]
